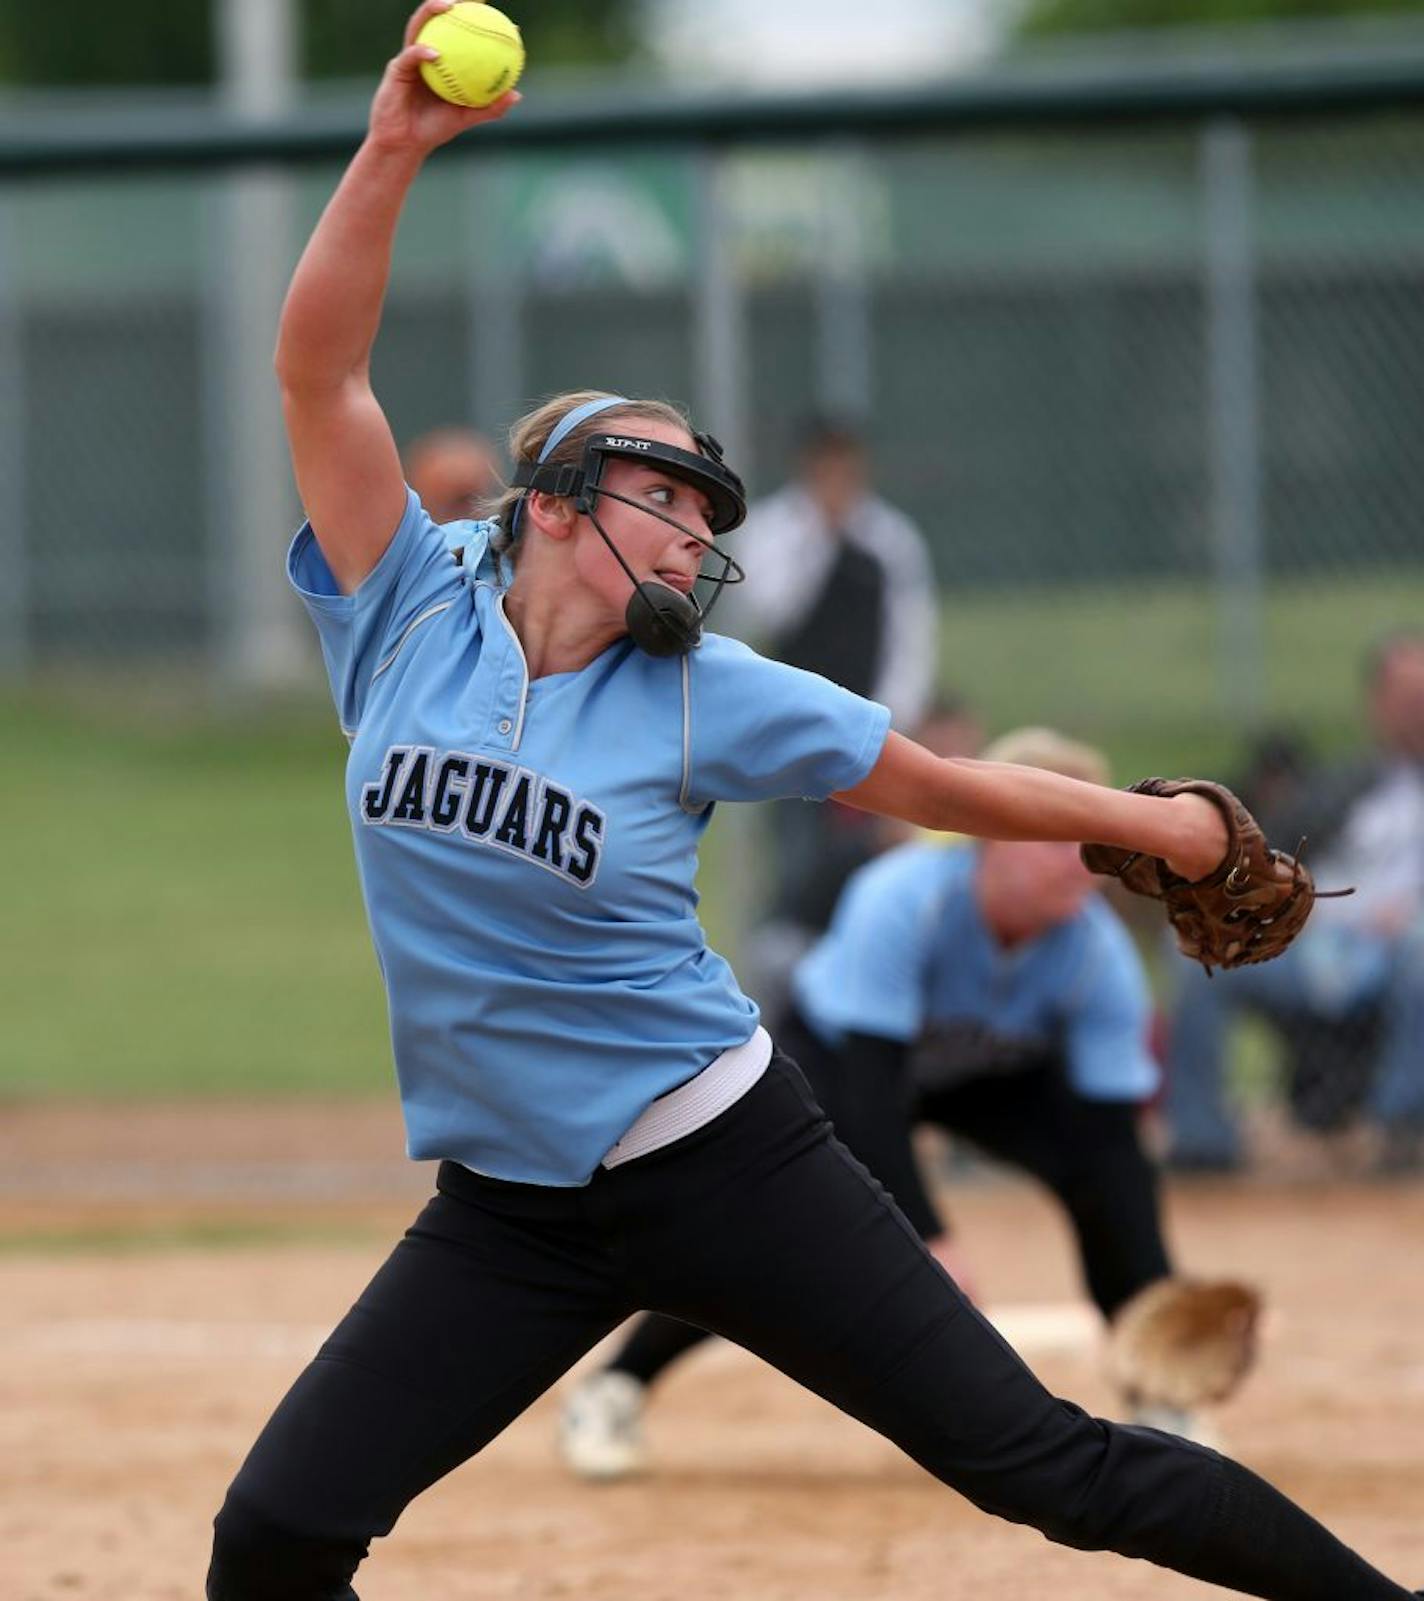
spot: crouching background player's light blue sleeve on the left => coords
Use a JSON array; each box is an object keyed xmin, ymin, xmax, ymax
[{"xmin": 793, "ymin": 845, "xmax": 945, "ymax": 1044}]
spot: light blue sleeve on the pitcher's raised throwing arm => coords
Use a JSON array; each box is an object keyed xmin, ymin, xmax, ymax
[{"xmin": 287, "ymin": 488, "xmax": 470, "ymax": 735}]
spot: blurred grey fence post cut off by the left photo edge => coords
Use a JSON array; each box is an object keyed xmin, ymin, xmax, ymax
[{"xmin": 0, "ymin": 195, "xmax": 30, "ymax": 679}]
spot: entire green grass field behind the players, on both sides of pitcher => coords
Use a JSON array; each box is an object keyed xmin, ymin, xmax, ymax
[{"xmin": 0, "ymin": 580, "xmax": 1424, "ymax": 1097}]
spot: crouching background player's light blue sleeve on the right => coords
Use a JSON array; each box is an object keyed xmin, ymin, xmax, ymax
[{"xmin": 1065, "ymin": 901, "xmax": 1161, "ymax": 1100}]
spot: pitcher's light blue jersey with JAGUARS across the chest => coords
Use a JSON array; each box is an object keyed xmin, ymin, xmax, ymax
[{"xmin": 288, "ymin": 492, "xmax": 889, "ymax": 1185}]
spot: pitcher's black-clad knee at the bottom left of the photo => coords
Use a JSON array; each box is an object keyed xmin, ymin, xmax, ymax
[{"xmin": 207, "ymin": 1494, "xmax": 367, "ymax": 1601}]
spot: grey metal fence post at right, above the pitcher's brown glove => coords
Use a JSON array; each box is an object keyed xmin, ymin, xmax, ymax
[{"xmin": 1201, "ymin": 117, "xmax": 1265, "ymax": 722}]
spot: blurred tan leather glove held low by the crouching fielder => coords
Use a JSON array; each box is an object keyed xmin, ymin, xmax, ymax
[{"xmin": 1107, "ymin": 1278, "xmax": 1261, "ymax": 1412}]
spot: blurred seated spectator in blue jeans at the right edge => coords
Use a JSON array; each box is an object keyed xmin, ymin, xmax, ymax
[{"xmin": 1166, "ymin": 631, "xmax": 1424, "ymax": 1172}]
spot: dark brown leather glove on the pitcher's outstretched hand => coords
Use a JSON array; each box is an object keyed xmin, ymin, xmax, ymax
[{"xmin": 1083, "ymin": 778, "xmax": 1326, "ymax": 973}]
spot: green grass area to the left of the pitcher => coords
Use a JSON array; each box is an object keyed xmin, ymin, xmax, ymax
[{"xmin": 0, "ymin": 701, "xmax": 389, "ymax": 1095}]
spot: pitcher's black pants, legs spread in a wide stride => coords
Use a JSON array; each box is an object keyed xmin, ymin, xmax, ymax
[{"xmin": 208, "ymin": 1055, "xmax": 1405, "ymax": 1601}]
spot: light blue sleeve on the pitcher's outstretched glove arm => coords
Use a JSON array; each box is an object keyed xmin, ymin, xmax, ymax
[{"xmin": 687, "ymin": 634, "xmax": 891, "ymax": 807}]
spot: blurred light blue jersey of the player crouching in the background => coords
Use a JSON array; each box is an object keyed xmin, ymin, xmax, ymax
[{"xmin": 793, "ymin": 844, "xmax": 1158, "ymax": 1100}]
